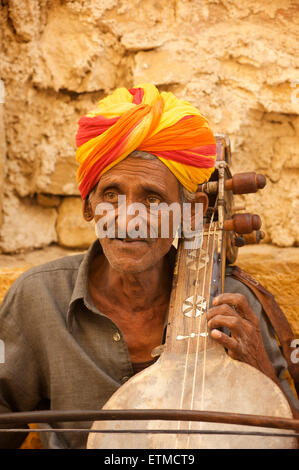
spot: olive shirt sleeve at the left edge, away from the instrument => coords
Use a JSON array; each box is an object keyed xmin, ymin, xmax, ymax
[{"xmin": 0, "ymin": 280, "xmax": 42, "ymax": 449}]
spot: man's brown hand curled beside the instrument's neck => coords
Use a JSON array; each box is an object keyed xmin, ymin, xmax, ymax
[{"xmin": 207, "ymin": 293, "xmax": 278, "ymax": 383}]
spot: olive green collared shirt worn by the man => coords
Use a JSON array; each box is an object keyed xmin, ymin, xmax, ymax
[{"xmin": 0, "ymin": 241, "xmax": 299, "ymax": 449}]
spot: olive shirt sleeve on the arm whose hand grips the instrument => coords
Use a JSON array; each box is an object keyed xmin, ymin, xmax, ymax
[{"xmin": 224, "ymin": 276, "xmax": 299, "ymax": 411}]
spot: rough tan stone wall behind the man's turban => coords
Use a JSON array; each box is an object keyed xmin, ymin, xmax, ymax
[{"xmin": 0, "ymin": 0, "xmax": 299, "ymax": 253}]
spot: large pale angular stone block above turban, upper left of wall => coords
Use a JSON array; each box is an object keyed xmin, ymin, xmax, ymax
[{"xmin": 33, "ymin": 6, "xmax": 119, "ymax": 93}]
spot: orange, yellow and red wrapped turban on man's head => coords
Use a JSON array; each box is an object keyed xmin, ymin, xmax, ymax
[{"xmin": 76, "ymin": 84, "xmax": 216, "ymax": 199}]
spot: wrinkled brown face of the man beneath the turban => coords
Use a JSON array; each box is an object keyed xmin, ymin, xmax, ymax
[{"xmin": 86, "ymin": 157, "xmax": 180, "ymax": 273}]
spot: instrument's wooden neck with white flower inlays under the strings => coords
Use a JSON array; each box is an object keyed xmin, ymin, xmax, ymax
[{"xmin": 163, "ymin": 223, "xmax": 221, "ymax": 357}]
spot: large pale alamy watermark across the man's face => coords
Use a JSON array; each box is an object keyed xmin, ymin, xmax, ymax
[{"xmin": 95, "ymin": 195, "xmax": 203, "ymax": 249}]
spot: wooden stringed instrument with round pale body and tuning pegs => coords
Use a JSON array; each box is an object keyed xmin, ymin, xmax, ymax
[{"xmin": 87, "ymin": 135, "xmax": 297, "ymax": 449}]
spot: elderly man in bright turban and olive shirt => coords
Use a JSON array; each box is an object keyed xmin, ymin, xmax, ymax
[{"xmin": 0, "ymin": 84, "xmax": 298, "ymax": 449}]
